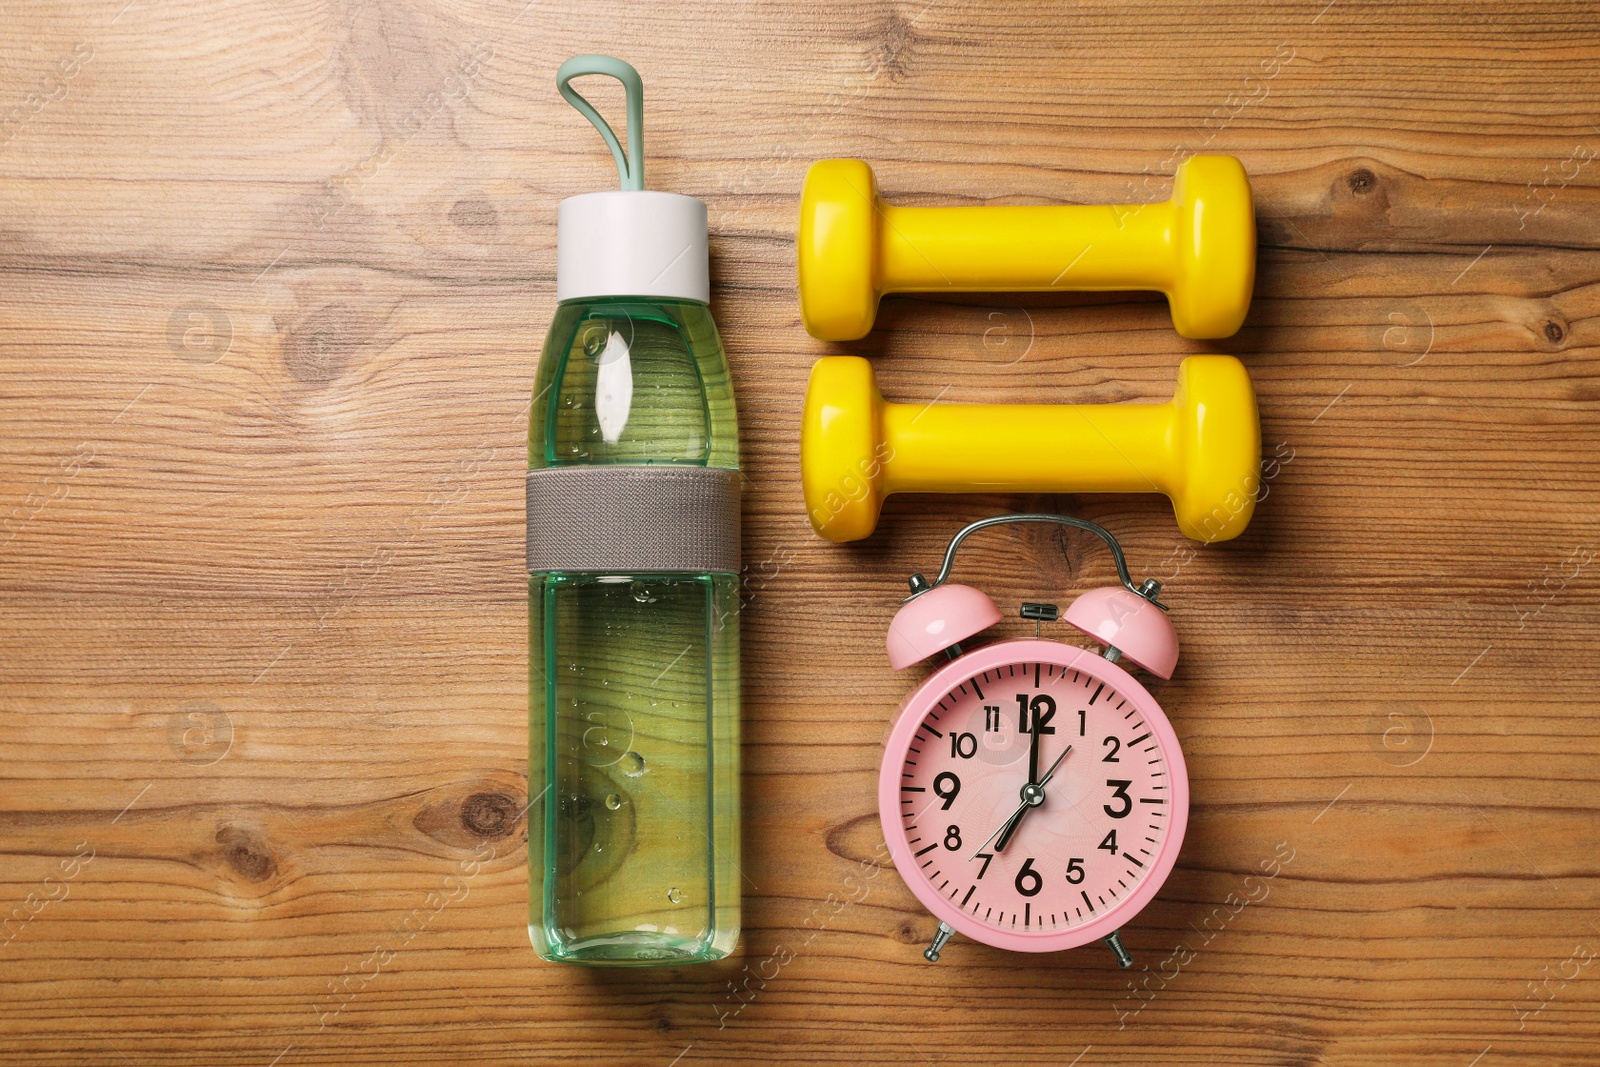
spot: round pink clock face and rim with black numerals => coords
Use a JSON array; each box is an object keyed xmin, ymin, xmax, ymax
[{"xmin": 880, "ymin": 640, "xmax": 1189, "ymax": 952}]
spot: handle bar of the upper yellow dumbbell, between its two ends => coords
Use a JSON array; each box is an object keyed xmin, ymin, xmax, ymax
[{"xmin": 875, "ymin": 202, "xmax": 1178, "ymax": 293}]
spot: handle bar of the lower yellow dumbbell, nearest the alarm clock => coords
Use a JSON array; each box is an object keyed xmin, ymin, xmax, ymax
[{"xmin": 882, "ymin": 402, "xmax": 1178, "ymax": 493}]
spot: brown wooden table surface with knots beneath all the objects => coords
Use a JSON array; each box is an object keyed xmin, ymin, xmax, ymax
[{"xmin": 0, "ymin": 0, "xmax": 1600, "ymax": 1067}]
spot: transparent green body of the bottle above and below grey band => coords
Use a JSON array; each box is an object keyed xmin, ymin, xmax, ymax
[{"xmin": 528, "ymin": 298, "xmax": 741, "ymax": 963}]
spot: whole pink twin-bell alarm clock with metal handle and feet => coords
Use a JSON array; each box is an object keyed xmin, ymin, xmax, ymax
[{"xmin": 878, "ymin": 514, "xmax": 1189, "ymax": 966}]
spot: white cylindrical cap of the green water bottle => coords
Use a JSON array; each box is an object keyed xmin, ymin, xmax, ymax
[{"xmin": 555, "ymin": 189, "xmax": 710, "ymax": 304}]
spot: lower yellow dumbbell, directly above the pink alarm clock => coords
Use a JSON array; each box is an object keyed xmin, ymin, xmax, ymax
[{"xmin": 800, "ymin": 355, "xmax": 1261, "ymax": 541}]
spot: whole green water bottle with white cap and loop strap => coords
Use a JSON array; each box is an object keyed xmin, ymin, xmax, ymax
[{"xmin": 528, "ymin": 56, "xmax": 741, "ymax": 965}]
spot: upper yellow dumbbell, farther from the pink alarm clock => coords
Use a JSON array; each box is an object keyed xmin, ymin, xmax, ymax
[{"xmin": 800, "ymin": 155, "xmax": 1256, "ymax": 341}]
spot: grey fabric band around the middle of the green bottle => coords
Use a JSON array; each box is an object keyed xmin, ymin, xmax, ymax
[{"xmin": 528, "ymin": 466, "xmax": 739, "ymax": 574}]
